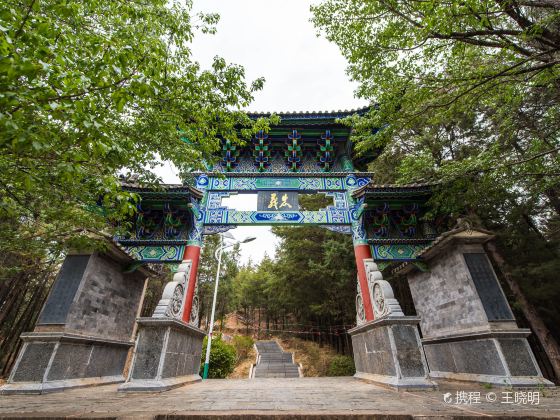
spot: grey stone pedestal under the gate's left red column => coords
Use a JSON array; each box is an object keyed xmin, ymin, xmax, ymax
[{"xmin": 119, "ymin": 318, "xmax": 205, "ymax": 392}]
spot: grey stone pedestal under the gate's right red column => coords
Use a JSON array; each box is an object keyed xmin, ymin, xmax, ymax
[{"xmin": 349, "ymin": 316, "xmax": 436, "ymax": 390}]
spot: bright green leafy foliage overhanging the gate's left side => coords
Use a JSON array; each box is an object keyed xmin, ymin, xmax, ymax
[{"xmin": 0, "ymin": 0, "xmax": 267, "ymax": 260}]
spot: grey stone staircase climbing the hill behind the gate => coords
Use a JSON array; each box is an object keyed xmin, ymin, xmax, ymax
[{"xmin": 250, "ymin": 341, "xmax": 303, "ymax": 378}]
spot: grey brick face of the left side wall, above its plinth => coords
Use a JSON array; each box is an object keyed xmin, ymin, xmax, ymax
[{"xmin": 65, "ymin": 253, "xmax": 144, "ymax": 341}]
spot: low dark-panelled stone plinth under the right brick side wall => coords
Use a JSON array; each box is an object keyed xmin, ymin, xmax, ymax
[{"xmin": 422, "ymin": 329, "xmax": 554, "ymax": 387}]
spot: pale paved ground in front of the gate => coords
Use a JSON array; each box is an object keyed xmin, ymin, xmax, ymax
[{"xmin": 0, "ymin": 377, "xmax": 560, "ymax": 420}]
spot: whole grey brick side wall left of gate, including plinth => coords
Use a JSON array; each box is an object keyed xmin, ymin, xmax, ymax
[{"xmin": 1, "ymin": 244, "xmax": 149, "ymax": 393}]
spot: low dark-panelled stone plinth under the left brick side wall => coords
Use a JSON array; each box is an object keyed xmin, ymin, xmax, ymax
[{"xmin": 0, "ymin": 332, "xmax": 133, "ymax": 394}]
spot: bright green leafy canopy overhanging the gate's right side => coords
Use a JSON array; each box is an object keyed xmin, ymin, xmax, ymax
[{"xmin": 313, "ymin": 0, "xmax": 560, "ymax": 214}]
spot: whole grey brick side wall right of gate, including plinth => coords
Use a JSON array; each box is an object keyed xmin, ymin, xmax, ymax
[{"xmin": 407, "ymin": 233, "xmax": 552, "ymax": 386}]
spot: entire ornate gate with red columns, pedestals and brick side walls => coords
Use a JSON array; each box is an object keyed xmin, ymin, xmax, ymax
[{"xmin": 0, "ymin": 110, "xmax": 551, "ymax": 393}]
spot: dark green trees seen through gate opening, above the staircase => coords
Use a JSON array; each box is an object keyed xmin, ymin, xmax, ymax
[{"xmin": 233, "ymin": 221, "xmax": 356, "ymax": 329}]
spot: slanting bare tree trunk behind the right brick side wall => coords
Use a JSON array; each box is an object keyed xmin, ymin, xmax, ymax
[{"xmin": 486, "ymin": 243, "xmax": 560, "ymax": 381}]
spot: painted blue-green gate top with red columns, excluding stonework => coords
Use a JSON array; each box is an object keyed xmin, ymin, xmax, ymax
[{"xmin": 118, "ymin": 109, "xmax": 435, "ymax": 324}]
